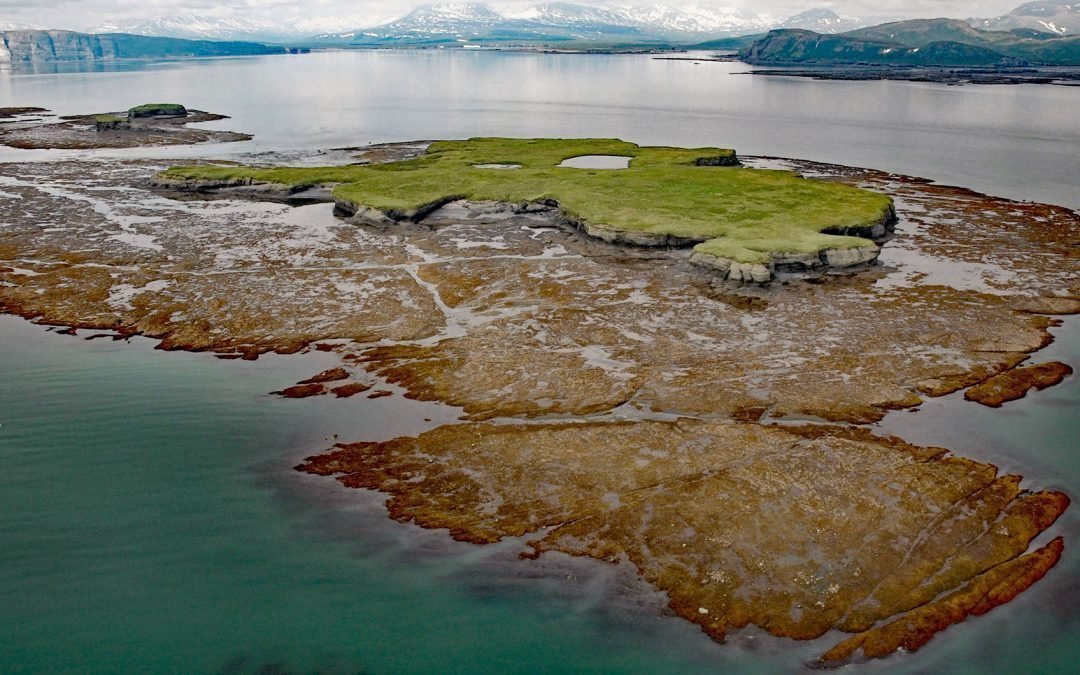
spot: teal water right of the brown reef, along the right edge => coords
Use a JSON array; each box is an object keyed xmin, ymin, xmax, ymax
[{"xmin": 879, "ymin": 316, "xmax": 1080, "ymax": 674}]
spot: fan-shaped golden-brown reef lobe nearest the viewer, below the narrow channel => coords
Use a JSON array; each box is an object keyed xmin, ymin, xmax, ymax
[{"xmin": 299, "ymin": 419, "xmax": 1068, "ymax": 661}]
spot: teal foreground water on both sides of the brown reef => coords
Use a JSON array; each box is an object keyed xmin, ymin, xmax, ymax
[{"xmin": 0, "ymin": 316, "xmax": 1080, "ymax": 673}]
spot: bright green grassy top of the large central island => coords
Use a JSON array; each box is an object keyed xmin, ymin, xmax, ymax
[{"xmin": 163, "ymin": 138, "xmax": 892, "ymax": 262}]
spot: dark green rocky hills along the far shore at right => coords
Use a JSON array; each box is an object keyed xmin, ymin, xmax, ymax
[{"xmin": 741, "ymin": 18, "xmax": 1080, "ymax": 67}]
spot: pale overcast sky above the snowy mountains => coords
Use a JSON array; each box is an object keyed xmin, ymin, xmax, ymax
[{"xmin": 0, "ymin": 0, "xmax": 1023, "ymax": 30}]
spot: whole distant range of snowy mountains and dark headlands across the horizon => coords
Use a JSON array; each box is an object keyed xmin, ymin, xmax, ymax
[{"xmin": 0, "ymin": 0, "xmax": 1080, "ymax": 66}]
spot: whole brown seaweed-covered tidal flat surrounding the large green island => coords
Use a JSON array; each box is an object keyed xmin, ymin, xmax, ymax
[{"xmin": 0, "ymin": 143, "xmax": 1080, "ymax": 662}]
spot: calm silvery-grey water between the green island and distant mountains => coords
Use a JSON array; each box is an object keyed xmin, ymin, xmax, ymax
[{"xmin": 0, "ymin": 50, "xmax": 1080, "ymax": 207}]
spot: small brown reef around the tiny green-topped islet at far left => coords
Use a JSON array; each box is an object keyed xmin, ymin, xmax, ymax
[{"xmin": 0, "ymin": 104, "xmax": 252, "ymax": 150}]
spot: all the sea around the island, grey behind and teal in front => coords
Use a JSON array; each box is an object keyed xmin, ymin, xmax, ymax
[{"xmin": 0, "ymin": 52, "xmax": 1080, "ymax": 673}]
